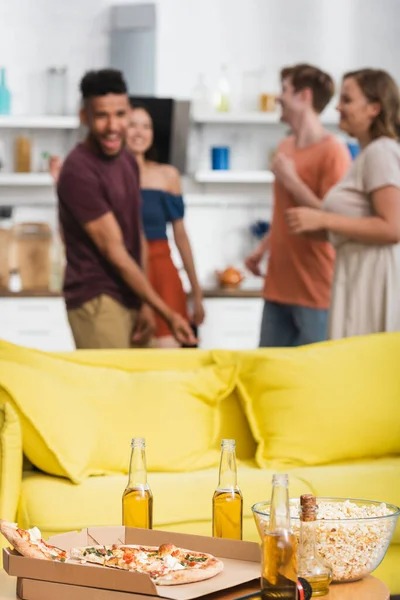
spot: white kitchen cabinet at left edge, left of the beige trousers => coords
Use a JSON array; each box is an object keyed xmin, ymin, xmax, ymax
[{"xmin": 0, "ymin": 297, "xmax": 75, "ymax": 352}]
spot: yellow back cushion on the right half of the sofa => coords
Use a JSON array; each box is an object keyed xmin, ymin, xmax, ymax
[{"xmin": 220, "ymin": 333, "xmax": 400, "ymax": 468}]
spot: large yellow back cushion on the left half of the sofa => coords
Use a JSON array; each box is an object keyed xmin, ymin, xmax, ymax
[{"xmin": 0, "ymin": 342, "xmax": 237, "ymax": 483}]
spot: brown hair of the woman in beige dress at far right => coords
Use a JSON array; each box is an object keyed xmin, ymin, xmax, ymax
[{"xmin": 343, "ymin": 69, "xmax": 400, "ymax": 140}]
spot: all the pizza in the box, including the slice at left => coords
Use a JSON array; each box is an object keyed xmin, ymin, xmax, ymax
[{"xmin": 0, "ymin": 520, "xmax": 224, "ymax": 585}]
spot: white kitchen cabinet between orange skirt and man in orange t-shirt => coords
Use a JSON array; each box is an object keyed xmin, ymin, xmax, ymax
[{"xmin": 199, "ymin": 298, "xmax": 264, "ymax": 350}]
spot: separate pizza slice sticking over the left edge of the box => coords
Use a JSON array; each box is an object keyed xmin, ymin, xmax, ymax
[{"xmin": 0, "ymin": 519, "xmax": 69, "ymax": 562}]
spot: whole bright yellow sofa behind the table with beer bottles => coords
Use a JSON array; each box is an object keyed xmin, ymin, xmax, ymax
[{"xmin": 0, "ymin": 334, "xmax": 400, "ymax": 594}]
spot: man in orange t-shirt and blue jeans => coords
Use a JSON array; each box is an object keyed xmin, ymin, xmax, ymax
[{"xmin": 246, "ymin": 64, "xmax": 351, "ymax": 346}]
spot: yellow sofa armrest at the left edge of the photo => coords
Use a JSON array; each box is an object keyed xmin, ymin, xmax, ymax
[{"xmin": 0, "ymin": 400, "xmax": 23, "ymax": 524}]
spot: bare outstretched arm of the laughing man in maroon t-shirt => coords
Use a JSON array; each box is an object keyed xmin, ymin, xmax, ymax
[{"xmin": 83, "ymin": 212, "xmax": 173, "ymax": 324}]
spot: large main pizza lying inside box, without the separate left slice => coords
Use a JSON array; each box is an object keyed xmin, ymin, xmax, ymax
[{"xmin": 70, "ymin": 544, "xmax": 224, "ymax": 585}]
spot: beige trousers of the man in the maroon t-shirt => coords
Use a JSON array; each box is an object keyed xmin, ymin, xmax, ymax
[{"xmin": 67, "ymin": 294, "xmax": 148, "ymax": 350}]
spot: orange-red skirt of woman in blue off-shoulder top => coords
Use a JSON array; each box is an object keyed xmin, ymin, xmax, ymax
[{"xmin": 147, "ymin": 240, "xmax": 188, "ymax": 337}]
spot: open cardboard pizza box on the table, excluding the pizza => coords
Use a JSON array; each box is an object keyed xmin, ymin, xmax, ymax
[{"xmin": 3, "ymin": 527, "xmax": 261, "ymax": 600}]
